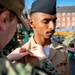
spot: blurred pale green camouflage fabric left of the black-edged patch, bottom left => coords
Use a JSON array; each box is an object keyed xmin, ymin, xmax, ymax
[{"xmin": 0, "ymin": 57, "xmax": 32, "ymax": 75}]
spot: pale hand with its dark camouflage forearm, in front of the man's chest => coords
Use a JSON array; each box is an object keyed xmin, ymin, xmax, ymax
[{"xmin": 30, "ymin": 44, "xmax": 58, "ymax": 75}]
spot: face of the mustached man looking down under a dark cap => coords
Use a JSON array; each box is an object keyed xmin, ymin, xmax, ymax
[{"xmin": 31, "ymin": 12, "xmax": 56, "ymax": 38}]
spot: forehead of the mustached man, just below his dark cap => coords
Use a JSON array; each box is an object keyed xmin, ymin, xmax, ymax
[{"xmin": 31, "ymin": 12, "xmax": 56, "ymax": 19}]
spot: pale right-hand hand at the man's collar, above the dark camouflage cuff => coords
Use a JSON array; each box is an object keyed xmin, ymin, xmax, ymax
[{"xmin": 30, "ymin": 44, "xmax": 47, "ymax": 60}]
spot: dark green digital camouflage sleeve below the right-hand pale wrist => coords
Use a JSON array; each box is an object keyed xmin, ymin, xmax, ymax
[{"xmin": 40, "ymin": 58, "xmax": 58, "ymax": 75}]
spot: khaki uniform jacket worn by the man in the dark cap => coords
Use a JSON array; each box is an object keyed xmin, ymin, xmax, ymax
[{"xmin": 18, "ymin": 36, "xmax": 71, "ymax": 75}]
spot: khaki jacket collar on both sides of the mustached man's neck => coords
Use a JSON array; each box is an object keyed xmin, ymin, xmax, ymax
[{"xmin": 30, "ymin": 36, "xmax": 63, "ymax": 59}]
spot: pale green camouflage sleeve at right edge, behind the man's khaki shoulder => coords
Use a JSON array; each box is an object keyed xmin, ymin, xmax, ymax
[{"xmin": 63, "ymin": 34, "xmax": 75, "ymax": 47}]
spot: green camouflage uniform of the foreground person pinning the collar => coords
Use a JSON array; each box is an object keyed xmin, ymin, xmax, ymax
[{"xmin": 0, "ymin": 52, "xmax": 57, "ymax": 75}]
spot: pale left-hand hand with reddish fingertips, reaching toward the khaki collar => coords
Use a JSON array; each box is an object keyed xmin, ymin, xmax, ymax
[{"xmin": 7, "ymin": 48, "xmax": 29, "ymax": 61}]
